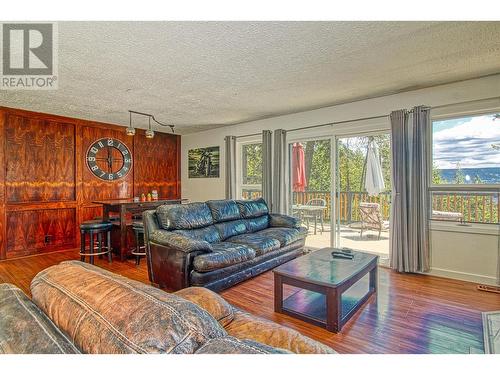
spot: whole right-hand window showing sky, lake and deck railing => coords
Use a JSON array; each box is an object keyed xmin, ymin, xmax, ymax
[{"xmin": 430, "ymin": 113, "xmax": 500, "ymax": 224}]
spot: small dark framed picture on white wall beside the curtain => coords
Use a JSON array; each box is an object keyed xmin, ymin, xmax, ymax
[{"xmin": 188, "ymin": 146, "xmax": 220, "ymax": 178}]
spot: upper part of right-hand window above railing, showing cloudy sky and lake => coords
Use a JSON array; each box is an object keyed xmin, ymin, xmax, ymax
[{"xmin": 432, "ymin": 113, "xmax": 500, "ymax": 185}]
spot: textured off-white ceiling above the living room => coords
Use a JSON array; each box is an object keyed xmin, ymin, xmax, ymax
[{"xmin": 0, "ymin": 22, "xmax": 500, "ymax": 133}]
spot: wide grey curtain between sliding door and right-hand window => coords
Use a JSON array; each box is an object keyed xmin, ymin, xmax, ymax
[{"xmin": 390, "ymin": 106, "xmax": 430, "ymax": 272}]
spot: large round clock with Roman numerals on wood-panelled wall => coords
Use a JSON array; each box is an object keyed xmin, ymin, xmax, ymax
[{"xmin": 87, "ymin": 138, "xmax": 132, "ymax": 181}]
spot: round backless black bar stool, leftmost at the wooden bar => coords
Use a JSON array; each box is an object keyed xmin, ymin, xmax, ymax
[{"xmin": 80, "ymin": 220, "xmax": 113, "ymax": 264}]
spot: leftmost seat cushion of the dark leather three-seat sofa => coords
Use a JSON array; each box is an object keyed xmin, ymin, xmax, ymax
[{"xmin": 193, "ymin": 242, "xmax": 255, "ymax": 272}]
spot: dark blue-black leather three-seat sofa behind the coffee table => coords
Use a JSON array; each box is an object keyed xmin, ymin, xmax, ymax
[{"xmin": 143, "ymin": 199, "xmax": 307, "ymax": 290}]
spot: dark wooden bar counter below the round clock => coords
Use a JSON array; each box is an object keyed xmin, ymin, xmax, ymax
[{"xmin": 92, "ymin": 199, "xmax": 187, "ymax": 261}]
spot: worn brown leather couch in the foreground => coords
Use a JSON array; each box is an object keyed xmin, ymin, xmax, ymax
[{"xmin": 0, "ymin": 261, "xmax": 334, "ymax": 354}]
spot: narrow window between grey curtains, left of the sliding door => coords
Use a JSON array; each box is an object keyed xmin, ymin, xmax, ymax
[{"xmin": 240, "ymin": 143, "xmax": 262, "ymax": 199}]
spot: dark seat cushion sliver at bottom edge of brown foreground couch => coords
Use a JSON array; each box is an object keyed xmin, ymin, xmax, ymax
[{"xmin": 196, "ymin": 336, "xmax": 290, "ymax": 354}]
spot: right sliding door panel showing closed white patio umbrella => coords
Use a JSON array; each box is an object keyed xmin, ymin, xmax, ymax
[{"xmin": 334, "ymin": 133, "xmax": 391, "ymax": 261}]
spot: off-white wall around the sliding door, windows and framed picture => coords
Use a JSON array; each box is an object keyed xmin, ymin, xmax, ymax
[{"xmin": 182, "ymin": 74, "xmax": 500, "ymax": 283}]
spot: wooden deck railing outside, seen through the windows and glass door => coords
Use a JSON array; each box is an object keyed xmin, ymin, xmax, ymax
[{"xmin": 243, "ymin": 190, "xmax": 500, "ymax": 224}]
